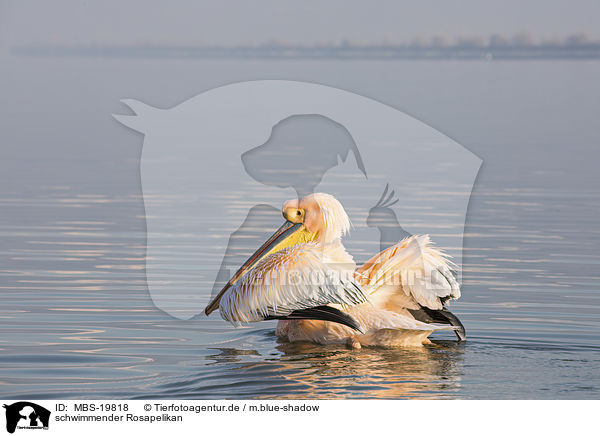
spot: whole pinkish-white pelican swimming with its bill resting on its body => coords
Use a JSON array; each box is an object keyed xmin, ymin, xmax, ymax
[{"xmin": 205, "ymin": 193, "xmax": 465, "ymax": 349}]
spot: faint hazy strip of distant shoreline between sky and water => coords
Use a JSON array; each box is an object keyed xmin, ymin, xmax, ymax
[{"xmin": 11, "ymin": 43, "xmax": 600, "ymax": 61}]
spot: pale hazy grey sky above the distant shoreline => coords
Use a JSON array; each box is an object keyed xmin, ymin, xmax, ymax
[{"xmin": 0, "ymin": 0, "xmax": 600, "ymax": 48}]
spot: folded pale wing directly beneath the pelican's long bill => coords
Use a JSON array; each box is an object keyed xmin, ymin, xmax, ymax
[{"xmin": 219, "ymin": 243, "xmax": 367, "ymax": 323}]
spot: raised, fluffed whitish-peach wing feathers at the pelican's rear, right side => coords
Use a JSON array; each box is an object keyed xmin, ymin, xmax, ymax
[{"xmin": 356, "ymin": 235, "xmax": 460, "ymax": 310}]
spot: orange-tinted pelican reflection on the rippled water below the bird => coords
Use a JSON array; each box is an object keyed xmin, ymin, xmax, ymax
[{"xmin": 206, "ymin": 341, "xmax": 464, "ymax": 399}]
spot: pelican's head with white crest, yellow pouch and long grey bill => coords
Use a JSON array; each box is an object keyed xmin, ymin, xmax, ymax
[{"xmin": 204, "ymin": 193, "xmax": 350, "ymax": 315}]
